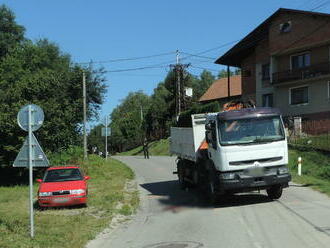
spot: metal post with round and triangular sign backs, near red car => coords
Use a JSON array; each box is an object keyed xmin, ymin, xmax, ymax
[{"xmin": 13, "ymin": 104, "xmax": 49, "ymax": 238}]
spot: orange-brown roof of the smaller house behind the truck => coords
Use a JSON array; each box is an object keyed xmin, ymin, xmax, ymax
[{"xmin": 199, "ymin": 75, "xmax": 242, "ymax": 102}]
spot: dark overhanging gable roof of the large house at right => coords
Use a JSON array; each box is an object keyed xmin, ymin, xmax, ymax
[{"xmin": 215, "ymin": 8, "xmax": 330, "ymax": 67}]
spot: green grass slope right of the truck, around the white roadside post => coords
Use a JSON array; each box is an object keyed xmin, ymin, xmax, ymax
[{"xmin": 289, "ymin": 149, "xmax": 330, "ymax": 196}]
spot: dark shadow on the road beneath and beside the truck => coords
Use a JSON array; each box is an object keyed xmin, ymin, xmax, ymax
[{"xmin": 140, "ymin": 180, "xmax": 272, "ymax": 208}]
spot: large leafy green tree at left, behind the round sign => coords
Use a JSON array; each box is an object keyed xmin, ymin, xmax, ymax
[{"xmin": 0, "ymin": 37, "xmax": 106, "ymax": 164}]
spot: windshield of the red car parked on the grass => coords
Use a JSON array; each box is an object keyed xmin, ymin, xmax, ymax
[{"xmin": 44, "ymin": 168, "xmax": 83, "ymax": 182}]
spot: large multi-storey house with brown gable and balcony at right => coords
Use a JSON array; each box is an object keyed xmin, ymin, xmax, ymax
[{"xmin": 215, "ymin": 8, "xmax": 330, "ymax": 126}]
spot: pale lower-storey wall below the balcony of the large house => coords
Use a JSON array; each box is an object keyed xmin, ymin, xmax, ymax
[{"xmin": 274, "ymin": 78, "xmax": 330, "ymax": 118}]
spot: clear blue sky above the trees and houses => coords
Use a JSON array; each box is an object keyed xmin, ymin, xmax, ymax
[{"xmin": 0, "ymin": 0, "xmax": 330, "ymax": 127}]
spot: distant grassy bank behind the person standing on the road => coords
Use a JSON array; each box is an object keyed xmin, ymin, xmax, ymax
[{"xmin": 118, "ymin": 139, "xmax": 170, "ymax": 156}]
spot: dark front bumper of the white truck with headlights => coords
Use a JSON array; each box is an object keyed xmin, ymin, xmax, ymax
[{"xmin": 219, "ymin": 173, "xmax": 291, "ymax": 193}]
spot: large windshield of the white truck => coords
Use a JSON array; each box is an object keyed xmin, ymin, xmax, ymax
[{"xmin": 219, "ymin": 116, "xmax": 285, "ymax": 145}]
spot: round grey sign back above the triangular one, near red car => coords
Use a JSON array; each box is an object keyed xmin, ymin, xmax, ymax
[{"xmin": 17, "ymin": 104, "xmax": 45, "ymax": 132}]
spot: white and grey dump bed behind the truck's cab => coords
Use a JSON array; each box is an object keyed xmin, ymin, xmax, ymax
[{"xmin": 170, "ymin": 114, "xmax": 206, "ymax": 162}]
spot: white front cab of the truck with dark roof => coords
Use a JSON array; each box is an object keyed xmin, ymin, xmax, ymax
[{"xmin": 205, "ymin": 108, "xmax": 291, "ymax": 198}]
